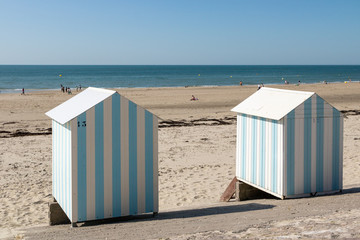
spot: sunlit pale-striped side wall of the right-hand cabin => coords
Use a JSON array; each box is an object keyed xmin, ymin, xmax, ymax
[{"xmin": 236, "ymin": 114, "xmax": 283, "ymax": 196}]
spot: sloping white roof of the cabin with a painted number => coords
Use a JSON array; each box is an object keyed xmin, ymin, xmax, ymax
[{"xmin": 45, "ymin": 87, "xmax": 116, "ymax": 124}]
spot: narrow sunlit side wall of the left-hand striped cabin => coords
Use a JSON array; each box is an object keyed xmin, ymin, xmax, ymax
[{"xmin": 52, "ymin": 120, "xmax": 72, "ymax": 219}]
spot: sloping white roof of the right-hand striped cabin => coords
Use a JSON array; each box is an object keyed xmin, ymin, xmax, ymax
[{"xmin": 231, "ymin": 87, "xmax": 315, "ymax": 120}]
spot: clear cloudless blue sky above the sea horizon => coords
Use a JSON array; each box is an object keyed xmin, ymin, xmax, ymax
[{"xmin": 0, "ymin": 0, "xmax": 360, "ymax": 65}]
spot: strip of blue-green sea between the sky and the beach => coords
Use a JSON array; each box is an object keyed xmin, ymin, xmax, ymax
[{"xmin": 0, "ymin": 65, "xmax": 360, "ymax": 93}]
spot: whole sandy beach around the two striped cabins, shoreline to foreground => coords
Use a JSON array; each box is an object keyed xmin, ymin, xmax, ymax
[{"xmin": 0, "ymin": 82, "xmax": 360, "ymax": 239}]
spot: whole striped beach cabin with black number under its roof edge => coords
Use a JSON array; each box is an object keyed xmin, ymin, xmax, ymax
[{"xmin": 46, "ymin": 87, "xmax": 158, "ymax": 223}]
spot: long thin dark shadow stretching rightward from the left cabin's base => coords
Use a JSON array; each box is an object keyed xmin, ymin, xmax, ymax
[{"xmin": 79, "ymin": 203, "xmax": 275, "ymax": 227}]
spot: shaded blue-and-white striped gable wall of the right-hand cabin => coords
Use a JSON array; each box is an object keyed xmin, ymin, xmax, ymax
[{"xmin": 284, "ymin": 95, "xmax": 343, "ymax": 196}]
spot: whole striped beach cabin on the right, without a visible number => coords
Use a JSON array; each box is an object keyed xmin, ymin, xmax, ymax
[{"xmin": 232, "ymin": 87, "xmax": 343, "ymax": 199}]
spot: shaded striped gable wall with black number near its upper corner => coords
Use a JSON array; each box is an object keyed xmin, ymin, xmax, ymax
[{"xmin": 71, "ymin": 94, "xmax": 158, "ymax": 222}]
